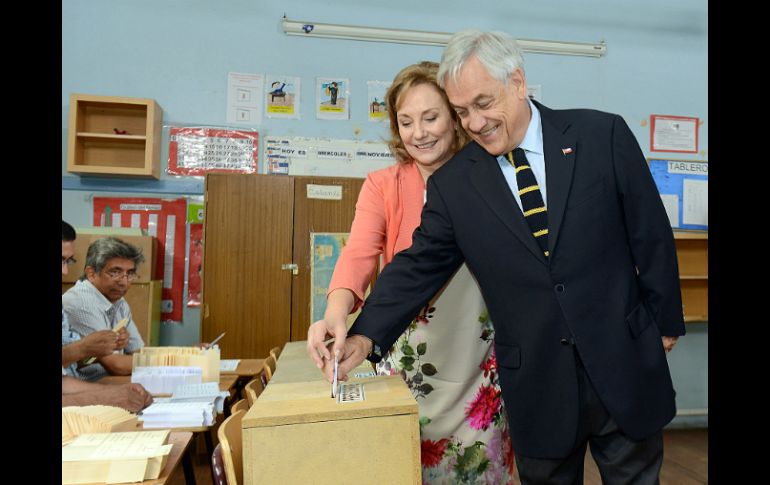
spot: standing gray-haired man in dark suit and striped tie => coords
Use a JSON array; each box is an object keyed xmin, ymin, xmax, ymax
[{"xmin": 308, "ymin": 31, "xmax": 685, "ymax": 484}]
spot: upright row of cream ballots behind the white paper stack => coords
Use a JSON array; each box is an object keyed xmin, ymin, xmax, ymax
[{"xmin": 132, "ymin": 346, "xmax": 219, "ymax": 382}]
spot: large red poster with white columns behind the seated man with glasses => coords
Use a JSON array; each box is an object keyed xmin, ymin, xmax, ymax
[{"xmin": 93, "ymin": 197, "xmax": 187, "ymax": 323}]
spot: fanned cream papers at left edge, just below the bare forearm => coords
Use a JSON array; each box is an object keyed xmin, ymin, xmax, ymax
[{"xmin": 61, "ymin": 406, "xmax": 137, "ymax": 445}]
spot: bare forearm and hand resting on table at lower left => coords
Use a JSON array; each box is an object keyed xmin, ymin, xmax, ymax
[{"xmin": 61, "ymin": 375, "xmax": 152, "ymax": 413}]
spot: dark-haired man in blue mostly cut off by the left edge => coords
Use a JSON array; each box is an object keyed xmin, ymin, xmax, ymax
[{"xmin": 61, "ymin": 221, "xmax": 128, "ymax": 377}]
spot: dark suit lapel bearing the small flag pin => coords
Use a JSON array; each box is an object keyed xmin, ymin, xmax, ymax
[{"xmin": 537, "ymin": 104, "xmax": 577, "ymax": 257}]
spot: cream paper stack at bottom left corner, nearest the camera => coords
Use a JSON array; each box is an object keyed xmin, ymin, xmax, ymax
[{"xmin": 61, "ymin": 430, "xmax": 173, "ymax": 485}]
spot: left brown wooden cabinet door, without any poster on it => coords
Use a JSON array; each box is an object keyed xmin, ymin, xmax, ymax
[{"xmin": 201, "ymin": 174, "xmax": 294, "ymax": 359}]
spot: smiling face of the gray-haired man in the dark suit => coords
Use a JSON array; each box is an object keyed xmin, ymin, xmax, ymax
[{"xmin": 445, "ymin": 56, "xmax": 532, "ymax": 156}]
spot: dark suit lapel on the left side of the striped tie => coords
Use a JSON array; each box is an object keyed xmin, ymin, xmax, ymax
[{"xmin": 470, "ymin": 146, "xmax": 550, "ymax": 264}]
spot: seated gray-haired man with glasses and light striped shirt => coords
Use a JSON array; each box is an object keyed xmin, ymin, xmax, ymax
[{"xmin": 62, "ymin": 237, "xmax": 144, "ymax": 381}]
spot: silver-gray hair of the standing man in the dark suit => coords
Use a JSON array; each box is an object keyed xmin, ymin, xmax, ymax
[{"xmin": 438, "ymin": 29, "xmax": 524, "ymax": 89}]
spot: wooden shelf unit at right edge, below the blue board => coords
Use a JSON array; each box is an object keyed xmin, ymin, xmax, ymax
[{"xmin": 674, "ymin": 231, "xmax": 709, "ymax": 322}]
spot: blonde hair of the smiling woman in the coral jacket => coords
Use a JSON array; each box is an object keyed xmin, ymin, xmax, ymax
[{"xmin": 385, "ymin": 61, "xmax": 470, "ymax": 163}]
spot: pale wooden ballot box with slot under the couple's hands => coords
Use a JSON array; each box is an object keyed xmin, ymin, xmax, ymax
[{"xmin": 243, "ymin": 342, "xmax": 422, "ymax": 485}]
